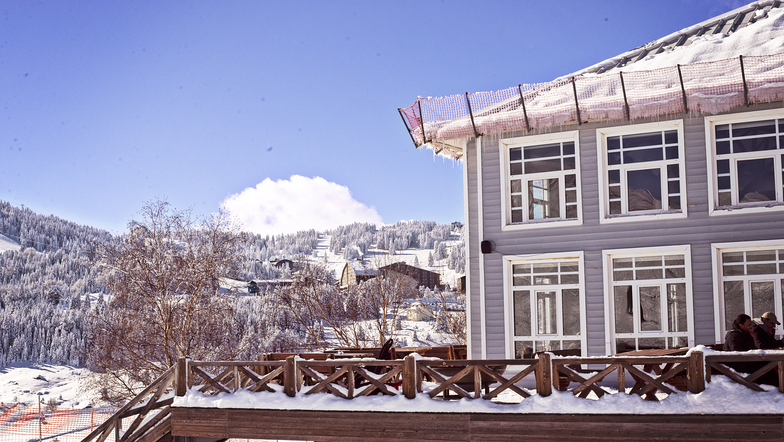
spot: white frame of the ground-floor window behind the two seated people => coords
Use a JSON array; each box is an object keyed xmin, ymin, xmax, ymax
[{"xmin": 711, "ymin": 239, "xmax": 784, "ymax": 344}]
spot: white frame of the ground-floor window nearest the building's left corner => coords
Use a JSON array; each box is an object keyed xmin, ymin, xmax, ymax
[{"xmin": 503, "ymin": 252, "xmax": 588, "ymax": 359}]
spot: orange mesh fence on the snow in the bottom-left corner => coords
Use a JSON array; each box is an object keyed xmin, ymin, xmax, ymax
[{"xmin": 0, "ymin": 403, "xmax": 117, "ymax": 442}]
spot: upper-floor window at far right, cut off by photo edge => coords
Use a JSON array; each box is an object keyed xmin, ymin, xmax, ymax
[{"xmin": 705, "ymin": 110, "xmax": 784, "ymax": 214}]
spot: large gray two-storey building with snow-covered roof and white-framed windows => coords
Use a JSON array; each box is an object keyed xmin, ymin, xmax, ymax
[{"xmin": 400, "ymin": 2, "xmax": 784, "ymax": 358}]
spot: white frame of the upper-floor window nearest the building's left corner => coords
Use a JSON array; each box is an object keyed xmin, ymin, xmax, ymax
[{"xmin": 498, "ymin": 131, "xmax": 583, "ymax": 231}]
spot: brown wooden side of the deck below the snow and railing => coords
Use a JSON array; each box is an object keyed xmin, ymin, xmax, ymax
[{"xmin": 171, "ymin": 407, "xmax": 784, "ymax": 442}]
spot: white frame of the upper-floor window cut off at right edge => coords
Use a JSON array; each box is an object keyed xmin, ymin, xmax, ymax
[{"xmin": 705, "ymin": 109, "xmax": 784, "ymax": 216}]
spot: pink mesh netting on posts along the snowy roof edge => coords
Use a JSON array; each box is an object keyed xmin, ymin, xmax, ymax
[{"xmin": 400, "ymin": 53, "xmax": 784, "ymax": 158}]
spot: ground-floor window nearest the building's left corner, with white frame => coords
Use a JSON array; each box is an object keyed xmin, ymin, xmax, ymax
[{"xmin": 505, "ymin": 253, "xmax": 585, "ymax": 358}]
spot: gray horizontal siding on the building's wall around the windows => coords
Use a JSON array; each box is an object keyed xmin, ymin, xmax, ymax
[{"xmin": 465, "ymin": 103, "xmax": 784, "ymax": 358}]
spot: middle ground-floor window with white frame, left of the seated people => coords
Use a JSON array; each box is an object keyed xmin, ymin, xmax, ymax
[{"xmin": 604, "ymin": 246, "xmax": 694, "ymax": 354}]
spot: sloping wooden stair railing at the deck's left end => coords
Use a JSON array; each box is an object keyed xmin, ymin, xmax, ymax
[{"xmin": 82, "ymin": 366, "xmax": 175, "ymax": 442}]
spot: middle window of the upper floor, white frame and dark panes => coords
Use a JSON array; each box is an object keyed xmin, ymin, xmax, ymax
[{"xmin": 596, "ymin": 121, "xmax": 686, "ymax": 222}]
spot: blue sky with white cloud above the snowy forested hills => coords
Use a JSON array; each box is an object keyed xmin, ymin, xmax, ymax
[{"xmin": 0, "ymin": 0, "xmax": 746, "ymax": 234}]
